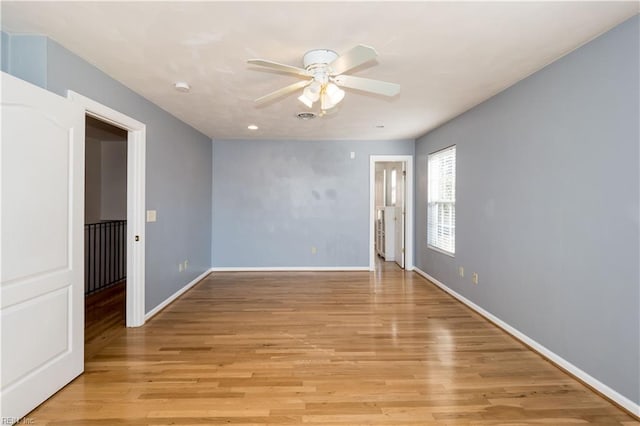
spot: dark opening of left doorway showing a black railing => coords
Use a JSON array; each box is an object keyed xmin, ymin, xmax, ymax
[{"xmin": 84, "ymin": 116, "xmax": 127, "ymax": 359}]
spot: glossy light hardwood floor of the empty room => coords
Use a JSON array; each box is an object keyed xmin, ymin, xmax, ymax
[{"xmin": 28, "ymin": 265, "xmax": 638, "ymax": 426}]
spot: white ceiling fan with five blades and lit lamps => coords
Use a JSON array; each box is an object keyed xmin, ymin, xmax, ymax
[{"xmin": 247, "ymin": 44, "xmax": 400, "ymax": 114}]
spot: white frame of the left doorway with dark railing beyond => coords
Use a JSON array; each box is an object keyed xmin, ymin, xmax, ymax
[{"xmin": 67, "ymin": 90, "xmax": 146, "ymax": 327}]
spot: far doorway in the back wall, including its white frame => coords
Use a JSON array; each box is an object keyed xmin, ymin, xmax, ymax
[{"xmin": 369, "ymin": 155, "xmax": 413, "ymax": 270}]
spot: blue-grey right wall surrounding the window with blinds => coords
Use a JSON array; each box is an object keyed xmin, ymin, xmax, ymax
[{"xmin": 416, "ymin": 16, "xmax": 640, "ymax": 403}]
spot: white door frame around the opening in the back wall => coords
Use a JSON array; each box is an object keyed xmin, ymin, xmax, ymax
[{"xmin": 369, "ymin": 155, "xmax": 414, "ymax": 271}]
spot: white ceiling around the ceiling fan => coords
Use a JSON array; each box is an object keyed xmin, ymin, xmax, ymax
[{"xmin": 1, "ymin": 1, "xmax": 639, "ymax": 140}]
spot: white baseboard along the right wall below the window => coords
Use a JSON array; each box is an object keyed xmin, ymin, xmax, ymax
[{"xmin": 414, "ymin": 267, "xmax": 640, "ymax": 417}]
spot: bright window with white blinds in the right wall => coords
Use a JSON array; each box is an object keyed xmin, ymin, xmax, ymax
[{"xmin": 427, "ymin": 145, "xmax": 456, "ymax": 255}]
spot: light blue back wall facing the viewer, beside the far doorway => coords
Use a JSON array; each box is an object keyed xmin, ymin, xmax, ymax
[{"xmin": 211, "ymin": 140, "xmax": 414, "ymax": 267}]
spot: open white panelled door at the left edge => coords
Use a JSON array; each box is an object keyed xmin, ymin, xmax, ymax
[{"xmin": 0, "ymin": 73, "xmax": 84, "ymax": 422}]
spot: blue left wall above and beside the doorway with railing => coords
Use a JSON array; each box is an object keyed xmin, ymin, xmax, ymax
[{"xmin": 1, "ymin": 36, "xmax": 211, "ymax": 312}]
